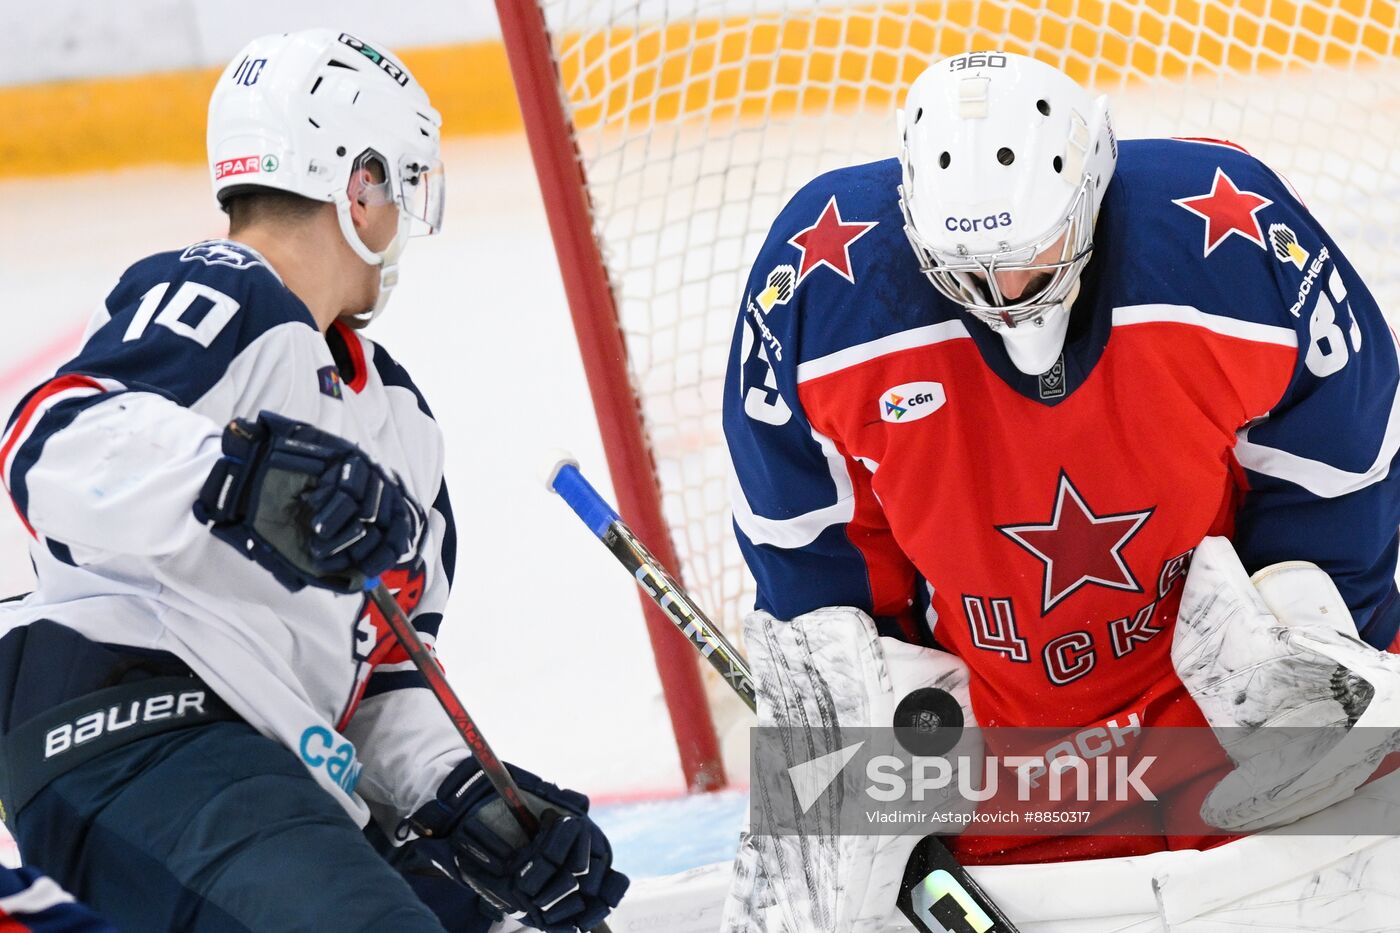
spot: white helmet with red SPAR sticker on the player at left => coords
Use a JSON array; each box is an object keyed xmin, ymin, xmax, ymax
[{"xmin": 209, "ymin": 29, "xmax": 445, "ymax": 315}]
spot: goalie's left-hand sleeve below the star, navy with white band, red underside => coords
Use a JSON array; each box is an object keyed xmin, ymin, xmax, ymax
[{"xmin": 724, "ymin": 179, "xmax": 914, "ymax": 637}]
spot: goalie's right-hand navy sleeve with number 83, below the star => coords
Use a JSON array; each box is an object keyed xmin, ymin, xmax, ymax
[{"xmin": 1235, "ymin": 185, "xmax": 1400, "ymax": 647}]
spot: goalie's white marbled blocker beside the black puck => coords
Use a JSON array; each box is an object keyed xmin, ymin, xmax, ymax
[{"xmin": 721, "ymin": 608, "xmax": 980, "ymax": 933}]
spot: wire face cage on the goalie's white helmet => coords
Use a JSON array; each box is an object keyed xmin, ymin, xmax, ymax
[{"xmin": 900, "ymin": 181, "xmax": 1093, "ymax": 326}]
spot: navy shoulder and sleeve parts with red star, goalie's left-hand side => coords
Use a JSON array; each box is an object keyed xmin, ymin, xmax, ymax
[{"xmin": 724, "ymin": 160, "xmax": 924, "ymax": 619}]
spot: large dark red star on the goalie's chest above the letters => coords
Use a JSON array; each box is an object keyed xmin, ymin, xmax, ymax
[{"xmin": 997, "ymin": 471, "xmax": 1152, "ymax": 615}]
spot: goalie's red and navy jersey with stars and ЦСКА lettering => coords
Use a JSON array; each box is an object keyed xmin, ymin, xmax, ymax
[{"xmin": 724, "ymin": 140, "xmax": 1400, "ymax": 862}]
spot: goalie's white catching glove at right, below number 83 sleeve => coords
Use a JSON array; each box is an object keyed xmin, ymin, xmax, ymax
[{"xmin": 1172, "ymin": 538, "xmax": 1400, "ymax": 831}]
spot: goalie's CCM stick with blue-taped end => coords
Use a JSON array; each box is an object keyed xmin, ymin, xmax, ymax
[{"xmin": 546, "ymin": 454, "xmax": 1016, "ymax": 933}]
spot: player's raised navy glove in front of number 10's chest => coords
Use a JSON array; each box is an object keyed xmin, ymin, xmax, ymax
[{"xmin": 195, "ymin": 412, "xmax": 424, "ymax": 593}]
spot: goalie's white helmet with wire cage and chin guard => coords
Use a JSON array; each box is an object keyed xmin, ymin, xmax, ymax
[{"xmin": 900, "ymin": 52, "xmax": 1117, "ymax": 375}]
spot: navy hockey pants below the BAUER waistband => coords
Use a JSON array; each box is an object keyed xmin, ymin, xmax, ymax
[{"xmin": 15, "ymin": 721, "xmax": 444, "ymax": 933}]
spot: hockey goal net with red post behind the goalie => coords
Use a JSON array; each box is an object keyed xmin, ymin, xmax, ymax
[{"xmin": 497, "ymin": 0, "xmax": 1400, "ymax": 789}]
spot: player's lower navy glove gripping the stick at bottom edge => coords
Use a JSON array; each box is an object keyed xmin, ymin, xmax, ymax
[{"xmin": 407, "ymin": 758, "xmax": 630, "ymax": 933}]
